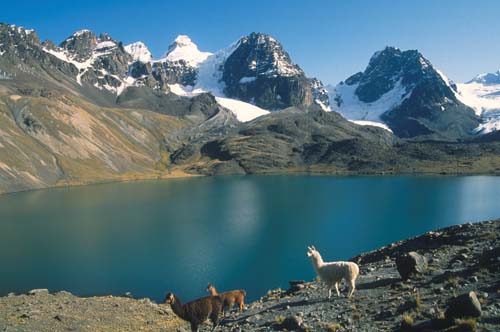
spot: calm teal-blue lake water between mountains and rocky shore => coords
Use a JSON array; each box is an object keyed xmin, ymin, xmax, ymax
[{"xmin": 0, "ymin": 176, "xmax": 500, "ymax": 301}]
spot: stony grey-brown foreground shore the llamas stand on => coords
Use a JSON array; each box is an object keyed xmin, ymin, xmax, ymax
[{"xmin": 0, "ymin": 220, "xmax": 500, "ymax": 332}]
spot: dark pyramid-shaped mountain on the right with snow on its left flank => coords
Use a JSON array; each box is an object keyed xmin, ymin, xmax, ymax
[{"xmin": 329, "ymin": 47, "xmax": 479, "ymax": 139}]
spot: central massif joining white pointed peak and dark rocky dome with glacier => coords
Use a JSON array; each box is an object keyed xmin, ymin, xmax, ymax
[{"xmin": 121, "ymin": 33, "xmax": 314, "ymax": 121}]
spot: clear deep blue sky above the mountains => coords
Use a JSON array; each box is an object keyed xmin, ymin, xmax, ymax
[{"xmin": 0, "ymin": 0, "xmax": 500, "ymax": 83}]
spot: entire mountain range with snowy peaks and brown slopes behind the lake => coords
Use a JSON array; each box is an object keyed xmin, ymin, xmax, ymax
[{"xmin": 0, "ymin": 24, "xmax": 500, "ymax": 192}]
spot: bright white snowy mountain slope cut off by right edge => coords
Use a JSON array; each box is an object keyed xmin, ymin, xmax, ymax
[{"xmin": 457, "ymin": 70, "xmax": 500, "ymax": 134}]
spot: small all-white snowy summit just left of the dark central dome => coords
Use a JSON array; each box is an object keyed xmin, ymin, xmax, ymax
[{"xmin": 162, "ymin": 35, "xmax": 212, "ymax": 67}]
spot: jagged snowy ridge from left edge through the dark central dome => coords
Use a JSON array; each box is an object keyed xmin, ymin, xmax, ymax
[{"xmin": 2, "ymin": 25, "xmax": 318, "ymax": 121}]
